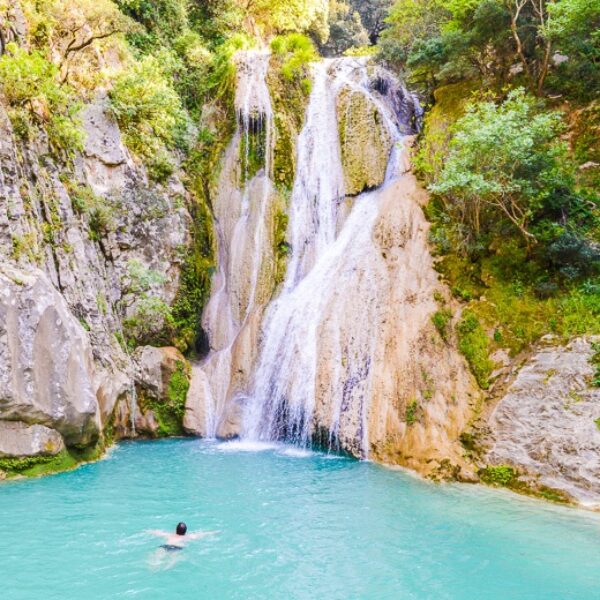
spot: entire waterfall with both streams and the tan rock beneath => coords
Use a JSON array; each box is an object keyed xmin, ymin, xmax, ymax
[{"xmin": 184, "ymin": 52, "xmax": 473, "ymax": 472}]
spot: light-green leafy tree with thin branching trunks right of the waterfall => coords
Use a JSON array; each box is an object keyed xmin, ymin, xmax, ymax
[{"xmin": 430, "ymin": 89, "xmax": 573, "ymax": 247}]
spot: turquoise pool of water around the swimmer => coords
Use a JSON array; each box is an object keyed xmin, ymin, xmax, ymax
[{"xmin": 0, "ymin": 440, "xmax": 600, "ymax": 600}]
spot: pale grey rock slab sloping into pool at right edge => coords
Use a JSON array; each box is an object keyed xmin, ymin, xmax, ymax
[{"xmin": 487, "ymin": 338, "xmax": 600, "ymax": 507}]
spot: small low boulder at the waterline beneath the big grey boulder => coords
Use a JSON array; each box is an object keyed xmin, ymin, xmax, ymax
[{"xmin": 0, "ymin": 421, "xmax": 65, "ymax": 458}]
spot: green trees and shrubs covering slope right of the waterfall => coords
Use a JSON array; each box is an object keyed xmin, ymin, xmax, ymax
[{"xmin": 378, "ymin": 0, "xmax": 600, "ymax": 387}]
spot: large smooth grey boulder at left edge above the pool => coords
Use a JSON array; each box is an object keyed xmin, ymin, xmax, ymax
[{"xmin": 0, "ymin": 266, "xmax": 100, "ymax": 444}]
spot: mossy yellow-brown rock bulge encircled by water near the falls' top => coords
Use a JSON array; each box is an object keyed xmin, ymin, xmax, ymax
[{"xmin": 337, "ymin": 88, "xmax": 392, "ymax": 196}]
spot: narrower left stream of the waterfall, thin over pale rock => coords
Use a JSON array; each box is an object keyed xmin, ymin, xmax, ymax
[{"xmin": 196, "ymin": 51, "xmax": 274, "ymax": 438}]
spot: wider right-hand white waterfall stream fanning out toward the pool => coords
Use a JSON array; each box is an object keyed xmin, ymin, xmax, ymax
[{"xmin": 241, "ymin": 59, "xmax": 412, "ymax": 456}]
